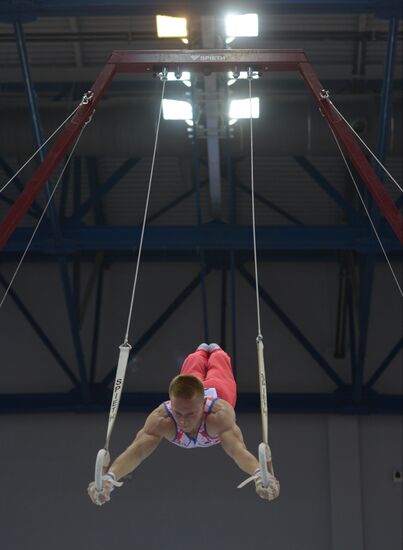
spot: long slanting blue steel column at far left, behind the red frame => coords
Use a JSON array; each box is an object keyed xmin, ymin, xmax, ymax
[{"xmin": 14, "ymin": 21, "xmax": 89, "ymax": 402}]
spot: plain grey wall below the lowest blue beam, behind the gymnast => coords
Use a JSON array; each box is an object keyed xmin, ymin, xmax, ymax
[{"xmin": 0, "ymin": 414, "xmax": 402, "ymax": 550}]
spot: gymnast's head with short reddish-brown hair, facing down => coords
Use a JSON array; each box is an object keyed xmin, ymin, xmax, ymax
[{"xmin": 169, "ymin": 374, "xmax": 204, "ymax": 432}]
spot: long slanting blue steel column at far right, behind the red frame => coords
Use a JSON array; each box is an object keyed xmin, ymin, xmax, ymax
[{"xmin": 353, "ymin": 17, "xmax": 399, "ymax": 403}]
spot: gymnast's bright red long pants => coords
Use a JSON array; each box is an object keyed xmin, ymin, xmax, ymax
[{"xmin": 181, "ymin": 348, "xmax": 236, "ymax": 407}]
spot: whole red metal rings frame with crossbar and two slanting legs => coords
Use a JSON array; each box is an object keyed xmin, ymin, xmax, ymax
[{"xmin": 0, "ymin": 50, "xmax": 403, "ymax": 249}]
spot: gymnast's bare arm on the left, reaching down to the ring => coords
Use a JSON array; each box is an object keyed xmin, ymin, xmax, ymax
[{"xmin": 108, "ymin": 407, "xmax": 167, "ymax": 480}]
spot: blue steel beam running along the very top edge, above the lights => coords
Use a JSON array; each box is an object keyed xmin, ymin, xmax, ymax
[{"xmin": 0, "ymin": 0, "xmax": 402, "ymax": 19}]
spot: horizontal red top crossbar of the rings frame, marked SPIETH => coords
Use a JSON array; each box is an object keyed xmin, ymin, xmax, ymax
[{"xmin": 108, "ymin": 50, "xmax": 307, "ymax": 73}]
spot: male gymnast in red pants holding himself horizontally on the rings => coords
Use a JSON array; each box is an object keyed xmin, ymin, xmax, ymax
[{"xmin": 88, "ymin": 344, "xmax": 280, "ymax": 506}]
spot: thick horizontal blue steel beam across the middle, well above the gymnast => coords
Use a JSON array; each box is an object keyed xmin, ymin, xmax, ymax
[{"xmin": 2, "ymin": 223, "xmax": 401, "ymax": 254}]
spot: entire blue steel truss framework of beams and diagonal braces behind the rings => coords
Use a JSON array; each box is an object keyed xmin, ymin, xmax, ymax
[{"xmin": 0, "ymin": 7, "xmax": 403, "ymax": 414}]
